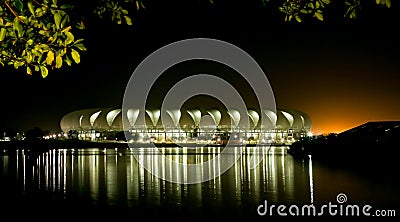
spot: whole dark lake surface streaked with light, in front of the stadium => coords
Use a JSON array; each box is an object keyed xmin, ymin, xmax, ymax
[{"xmin": 0, "ymin": 147, "xmax": 399, "ymax": 220}]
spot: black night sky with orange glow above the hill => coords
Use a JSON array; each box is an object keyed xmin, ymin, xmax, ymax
[{"xmin": 0, "ymin": 1, "xmax": 400, "ymax": 133}]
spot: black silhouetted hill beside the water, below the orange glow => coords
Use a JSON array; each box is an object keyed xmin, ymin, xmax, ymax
[{"xmin": 288, "ymin": 121, "xmax": 400, "ymax": 181}]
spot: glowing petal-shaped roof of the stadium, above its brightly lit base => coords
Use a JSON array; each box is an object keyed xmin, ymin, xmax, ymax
[{"xmin": 60, "ymin": 108, "xmax": 311, "ymax": 132}]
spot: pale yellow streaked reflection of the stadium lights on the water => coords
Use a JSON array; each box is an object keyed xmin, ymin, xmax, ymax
[{"xmin": 3, "ymin": 147, "xmax": 310, "ymax": 211}]
